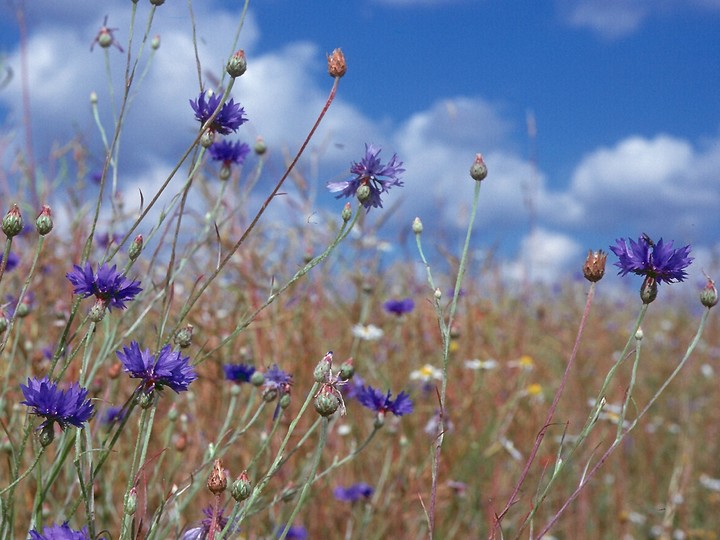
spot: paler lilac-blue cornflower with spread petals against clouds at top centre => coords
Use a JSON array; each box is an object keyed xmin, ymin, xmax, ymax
[{"xmin": 327, "ymin": 143, "xmax": 405, "ymax": 211}]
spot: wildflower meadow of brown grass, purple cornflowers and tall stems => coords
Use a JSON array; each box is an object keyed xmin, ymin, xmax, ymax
[{"xmin": 0, "ymin": 4, "xmax": 720, "ymax": 540}]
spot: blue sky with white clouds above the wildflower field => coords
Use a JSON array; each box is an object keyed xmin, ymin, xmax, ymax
[{"xmin": 0, "ymin": 0, "xmax": 720, "ymax": 286}]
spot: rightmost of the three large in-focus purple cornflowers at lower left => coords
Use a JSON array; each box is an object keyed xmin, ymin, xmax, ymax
[{"xmin": 115, "ymin": 341, "xmax": 197, "ymax": 394}]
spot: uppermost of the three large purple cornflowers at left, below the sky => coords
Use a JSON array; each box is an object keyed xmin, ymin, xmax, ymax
[{"xmin": 65, "ymin": 263, "xmax": 142, "ymax": 309}]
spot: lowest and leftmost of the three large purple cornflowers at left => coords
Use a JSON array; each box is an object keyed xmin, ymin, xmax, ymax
[{"xmin": 20, "ymin": 377, "xmax": 94, "ymax": 429}]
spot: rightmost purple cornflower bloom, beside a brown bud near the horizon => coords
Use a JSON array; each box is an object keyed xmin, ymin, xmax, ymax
[{"xmin": 610, "ymin": 235, "xmax": 693, "ymax": 283}]
